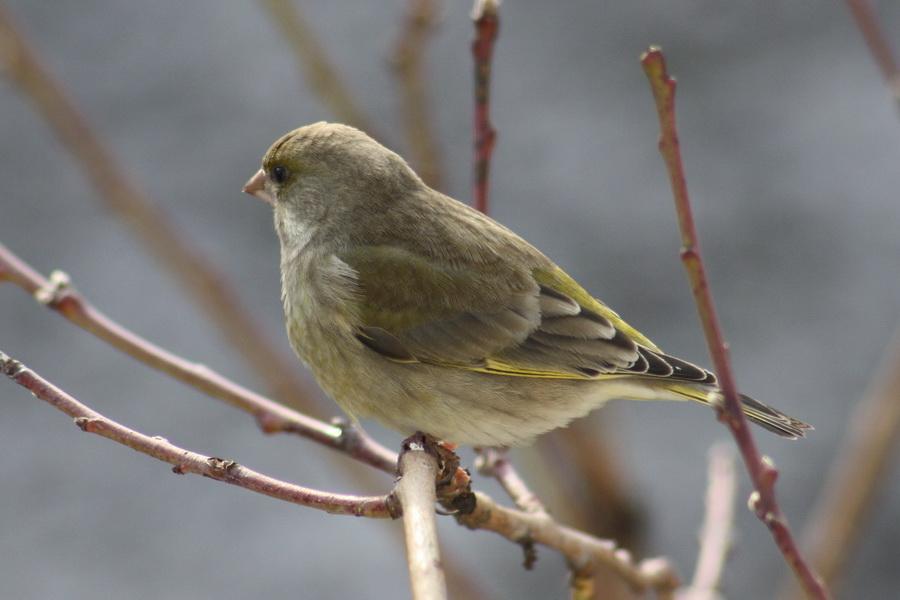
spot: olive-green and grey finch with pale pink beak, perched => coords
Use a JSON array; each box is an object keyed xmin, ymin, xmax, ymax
[{"xmin": 243, "ymin": 122, "xmax": 812, "ymax": 446}]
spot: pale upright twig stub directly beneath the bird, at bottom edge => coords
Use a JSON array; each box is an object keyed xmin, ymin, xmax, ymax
[{"xmin": 394, "ymin": 438, "xmax": 447, "ymax": 600}]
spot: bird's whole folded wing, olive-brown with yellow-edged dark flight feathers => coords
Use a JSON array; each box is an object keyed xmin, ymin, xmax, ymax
[{"xmin": 338, "ymin": 246, "xmax": 714, "ymax": 382}]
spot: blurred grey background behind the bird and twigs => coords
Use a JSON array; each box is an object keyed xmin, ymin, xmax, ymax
[{"xmin": 0, "ymin": 0, "xmax": 900, "ymax": 600}]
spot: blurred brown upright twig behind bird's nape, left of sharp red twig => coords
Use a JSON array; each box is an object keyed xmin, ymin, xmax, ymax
[{"xmin": 391, "ymin": 0, "xmax": 444, "ymax": 190}]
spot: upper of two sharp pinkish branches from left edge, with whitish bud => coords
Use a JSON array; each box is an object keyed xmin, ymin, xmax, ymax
[{"xmin": 0, "ymin": 244, "xmax": 397, "ymax": 473}]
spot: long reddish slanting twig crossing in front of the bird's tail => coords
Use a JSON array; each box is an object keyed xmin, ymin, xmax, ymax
[{"xmin": 641, "ymin": 47, "xmax": 829, "ymax": 599}]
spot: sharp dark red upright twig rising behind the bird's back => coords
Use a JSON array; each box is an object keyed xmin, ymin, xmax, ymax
[{"xmin": 472, "ymin": 0, "xmax": 500, "ymax": 214}]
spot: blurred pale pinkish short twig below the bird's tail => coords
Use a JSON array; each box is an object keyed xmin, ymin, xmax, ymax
[{"xmin": 678, "ymin": 443, "xmax": 737, "ymax": 600}]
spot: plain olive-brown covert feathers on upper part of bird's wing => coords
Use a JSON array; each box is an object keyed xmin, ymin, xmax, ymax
[{"xmin": 338, "ymin": 246, "xmax": 541, "ymax": 368}]
